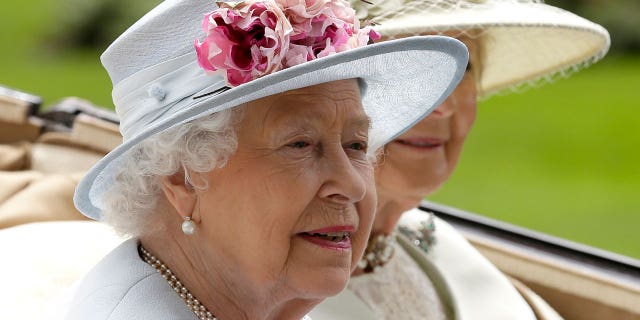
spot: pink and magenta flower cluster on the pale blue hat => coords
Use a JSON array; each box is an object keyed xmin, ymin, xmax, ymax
[{"xmin": 195, "ymin": 0, "xmax": 380, "ymax": 86}]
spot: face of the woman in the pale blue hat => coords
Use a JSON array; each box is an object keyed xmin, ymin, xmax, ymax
[{"xmin": 196, "ymin": 79, "xmax": 376, "ymax": 299}]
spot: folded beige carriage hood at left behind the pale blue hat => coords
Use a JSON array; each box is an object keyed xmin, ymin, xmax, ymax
[{"xmin": 0, "ymin": 96, "xmax": 122, "ymax": 228}]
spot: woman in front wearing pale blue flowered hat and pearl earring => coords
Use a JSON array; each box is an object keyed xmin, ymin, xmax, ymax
[{"xmin": 61, "ymin": 0, "xmax": 468, "ymax": 319}]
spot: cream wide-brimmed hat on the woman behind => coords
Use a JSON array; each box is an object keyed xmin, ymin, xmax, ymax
[{"xmin": 351, "ymin": 0, "xmax": 611, "ymax": 96}]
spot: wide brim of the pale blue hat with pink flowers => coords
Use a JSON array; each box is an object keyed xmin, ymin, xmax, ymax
[{"xmin": 74, "ymin": 36, "xmax": 468, "ymax": 220}]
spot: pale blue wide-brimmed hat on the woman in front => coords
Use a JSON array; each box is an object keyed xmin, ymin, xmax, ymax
[{"xmin": 74, "ymin": 0, "xmax": 468, "ymax": 219}]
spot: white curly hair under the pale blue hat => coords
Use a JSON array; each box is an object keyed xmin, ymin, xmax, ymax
[{"xmin": 102, "ymin": 107, "xmax": 244, "ymax": 237}]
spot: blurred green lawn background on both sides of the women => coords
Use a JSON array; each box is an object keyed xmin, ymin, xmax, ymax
[{"xmin": 0, "ymin": 0, "xmax": 640, "ymax": 258}]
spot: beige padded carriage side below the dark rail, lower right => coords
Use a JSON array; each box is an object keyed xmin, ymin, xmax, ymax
[{"xmin": 464, "ymin": 232, "xmax": 640, "ymax": 320}]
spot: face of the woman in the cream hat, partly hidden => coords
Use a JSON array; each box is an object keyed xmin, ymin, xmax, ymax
[{"xmin": 376, "ymin": 38, "xmax": 479, "ymax": 206}]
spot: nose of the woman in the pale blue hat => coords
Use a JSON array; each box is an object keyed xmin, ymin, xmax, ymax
[{"xmin": 319, "ymin": 148, "xmax": 373, "ymax": 204}]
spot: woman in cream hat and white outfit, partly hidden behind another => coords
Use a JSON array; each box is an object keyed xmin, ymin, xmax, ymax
[{"xmin": 312, "ymin": 0, "xmax": 609, "ymax": 319}]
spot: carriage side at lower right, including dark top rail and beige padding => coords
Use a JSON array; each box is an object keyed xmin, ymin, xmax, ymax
[{"xmin": 421, "ymin": 201, "xmax": 640, "ymax": 320}]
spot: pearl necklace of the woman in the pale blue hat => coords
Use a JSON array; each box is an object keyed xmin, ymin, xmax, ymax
[{"xmin": 138, "ymin": 245, "xmax": 217, "ymax": 320}]
